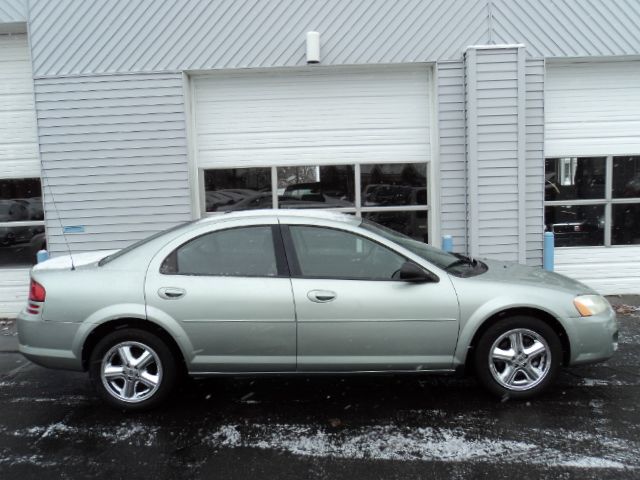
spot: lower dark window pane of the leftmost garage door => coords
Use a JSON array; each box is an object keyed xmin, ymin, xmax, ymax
[{"xmin": 0, "ymin": 225, "xmax": 46, "ymax": 267}]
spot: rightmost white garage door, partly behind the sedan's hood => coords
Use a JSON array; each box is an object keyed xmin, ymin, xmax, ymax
[{"xmin": 545, "ymin": 61, "xmax": 640, "ymax": 294}]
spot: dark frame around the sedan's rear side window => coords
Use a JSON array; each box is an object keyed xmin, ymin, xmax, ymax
[{"xmin": 158, "ymin": 223, "xmax": 290, "ymax": 279}]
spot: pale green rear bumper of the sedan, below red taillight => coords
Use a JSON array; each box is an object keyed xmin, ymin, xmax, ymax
[{"xmin": 17, "ymin": 310, "xmax": 83, "ymax": 371}]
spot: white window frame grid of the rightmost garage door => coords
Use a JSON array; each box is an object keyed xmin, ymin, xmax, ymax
[{"xmin": 543, "ymin": 154, "xmax": 640, "ymax": 249}]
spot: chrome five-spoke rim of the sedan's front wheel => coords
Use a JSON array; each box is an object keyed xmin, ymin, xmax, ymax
[{"xmin": 489, "ymin": 328, "xmax": 551, "ymax": 391}]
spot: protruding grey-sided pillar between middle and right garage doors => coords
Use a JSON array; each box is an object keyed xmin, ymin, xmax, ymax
[{"xmin": 466, "ymin": 48, "xmax": 524, "ymax": 261}]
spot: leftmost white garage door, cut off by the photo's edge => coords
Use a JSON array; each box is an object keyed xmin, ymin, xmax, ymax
[{"xmin": 0, "ymin": 35, "xmax": 44, "ymax": 317}]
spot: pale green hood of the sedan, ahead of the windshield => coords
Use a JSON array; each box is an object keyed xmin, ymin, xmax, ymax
[{"xmin": 472, "ymin": 259, "xmax": 597, "ymax": 294}]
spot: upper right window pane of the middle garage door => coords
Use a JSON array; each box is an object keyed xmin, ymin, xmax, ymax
[{"xmin": 360, "ymin": 163, "xmax": 427, "ymax": 207}]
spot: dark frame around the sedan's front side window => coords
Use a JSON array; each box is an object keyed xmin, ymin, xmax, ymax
[{"xmin": 280, "ymin": 223, "xmax": 430, "ymax": 283}]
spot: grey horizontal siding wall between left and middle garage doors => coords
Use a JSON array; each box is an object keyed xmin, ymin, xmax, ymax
[{"xmin": 35, "ymin": 74, "xmax": 191, "ymax": 254}]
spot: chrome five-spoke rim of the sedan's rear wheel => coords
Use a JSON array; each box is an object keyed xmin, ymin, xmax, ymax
[{"xmin": 100, "ymin": 341, "xmax": 162, "ymax": 403}]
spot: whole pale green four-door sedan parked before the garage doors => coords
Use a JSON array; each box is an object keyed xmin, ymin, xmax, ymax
[{"xmin": 18, "ymin": 210, "xmax": 618, "ymax": 410}]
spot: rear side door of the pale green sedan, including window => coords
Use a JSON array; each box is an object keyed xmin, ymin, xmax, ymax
[{"xmin": 145, "ymin": 222, "xmax": 296, "ymax": 372}]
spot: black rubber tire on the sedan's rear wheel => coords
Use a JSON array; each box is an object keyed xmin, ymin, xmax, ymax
[{"xmin": 89, "ymin": 328, "xmax": 178, "ymax": 411}]
